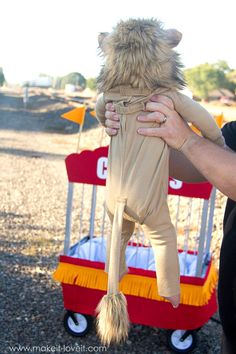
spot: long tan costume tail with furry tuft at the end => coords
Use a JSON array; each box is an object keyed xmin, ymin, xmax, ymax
[{"xmin": 96, "ymin": 198, "xmax": 129, "ymax": 346}]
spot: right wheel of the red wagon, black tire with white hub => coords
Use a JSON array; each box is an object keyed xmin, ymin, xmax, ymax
[{"xmin": 168, "ymin": 329, "xmax": 197, "ymax": 353}]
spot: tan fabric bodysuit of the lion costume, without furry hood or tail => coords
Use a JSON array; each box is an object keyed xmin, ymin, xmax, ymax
[{"xmin": 96, "ymin": 86, "xmax": 224, "ymax": 296}]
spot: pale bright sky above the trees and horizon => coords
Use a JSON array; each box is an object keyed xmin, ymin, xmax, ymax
[{"xmin": 0, "ymin": 0, "xmax": 236, "ymax": 83}]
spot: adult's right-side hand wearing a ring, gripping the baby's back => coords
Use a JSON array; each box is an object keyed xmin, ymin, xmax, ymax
[{"xmin": 137, "ymin": 96, "xmax": 196, "ymax": 150}]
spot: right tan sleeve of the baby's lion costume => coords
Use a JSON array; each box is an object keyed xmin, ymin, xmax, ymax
[{"xmin": 171, "ymin": 91, "xmax": 225, "ymax": 146}]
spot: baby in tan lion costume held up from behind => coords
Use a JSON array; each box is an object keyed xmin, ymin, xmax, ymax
[{"xmin": 96, "ymin": 19, "xmax": 224, "ymax": 344}]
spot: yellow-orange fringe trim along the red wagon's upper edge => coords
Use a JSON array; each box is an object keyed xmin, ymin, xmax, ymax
[{"xmin": 53, "ymin": 262, "xmax": 218, "ymax": 306}]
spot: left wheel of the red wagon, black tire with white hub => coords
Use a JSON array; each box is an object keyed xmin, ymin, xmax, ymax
[{"xmin": 63, "ymin": 311, "xmax": 92, "ymax": 337}]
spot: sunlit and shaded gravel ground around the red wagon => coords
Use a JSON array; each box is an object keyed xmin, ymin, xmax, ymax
[{"xmin": 0, "ymin": 91, "xmax": 221, "ymax": 354}]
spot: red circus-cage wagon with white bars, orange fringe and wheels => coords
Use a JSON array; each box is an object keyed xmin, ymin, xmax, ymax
[{"xmin": 54, "ymin": 147, "xmax": 217, "ymax": 353}]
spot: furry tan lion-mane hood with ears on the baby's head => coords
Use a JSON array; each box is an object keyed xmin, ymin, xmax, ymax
[{"xmin": 97, "ymin": 19, "xmax": 185, "ymax": 92}]
